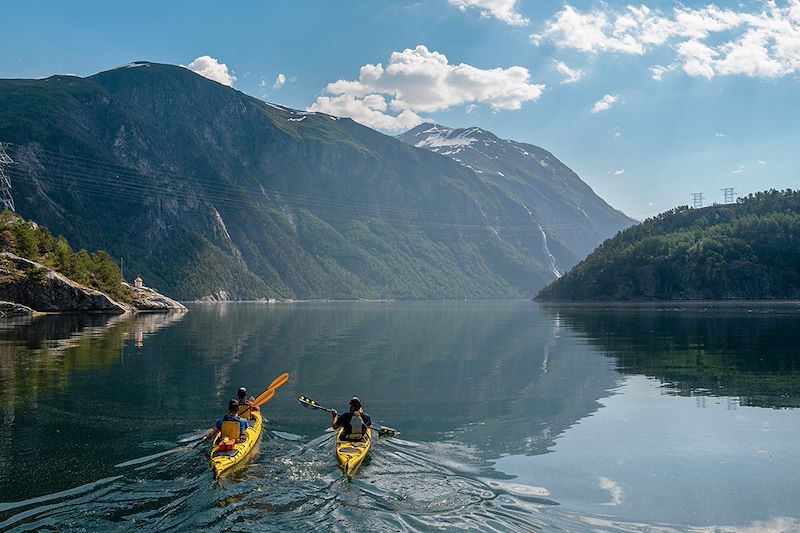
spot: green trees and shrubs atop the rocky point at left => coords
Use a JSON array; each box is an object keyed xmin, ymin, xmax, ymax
[{"xmin": 0, "ymin": 211, "xmax": 131, "ymax": 302}]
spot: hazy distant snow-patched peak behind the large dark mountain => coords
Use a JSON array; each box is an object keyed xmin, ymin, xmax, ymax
[{"xmin": 398, "ymin": 123, "xmax": 635, "ymax": 275}]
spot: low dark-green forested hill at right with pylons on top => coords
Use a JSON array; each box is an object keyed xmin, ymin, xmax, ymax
[{"xmin": 537, "ymin": 190, "xmax": 800, "ymax": 300}]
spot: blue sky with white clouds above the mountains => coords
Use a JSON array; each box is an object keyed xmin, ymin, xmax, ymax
[{"xmin": 0, "ymin": 0, "xmax": 800, "ymax": 218}]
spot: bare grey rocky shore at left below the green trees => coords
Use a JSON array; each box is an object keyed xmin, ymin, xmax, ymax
[{"xmin": 0, "ymin": 252, "xmax": 186, "ymax": 316}]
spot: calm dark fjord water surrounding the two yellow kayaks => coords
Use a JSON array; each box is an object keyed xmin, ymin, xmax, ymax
[{"xmin": 0, "ymin": 302, "xmax": 800, "ymax": 532}]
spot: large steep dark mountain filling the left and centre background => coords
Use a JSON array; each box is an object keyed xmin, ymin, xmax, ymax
[{"xmin": 0, "ymin": 62, "xmax": 625, "ymax": 299}]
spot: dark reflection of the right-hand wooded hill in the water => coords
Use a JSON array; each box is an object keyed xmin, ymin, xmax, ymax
[{"xmin": 546, "ymin": 302, "xmax": 800, "ymax": 408}]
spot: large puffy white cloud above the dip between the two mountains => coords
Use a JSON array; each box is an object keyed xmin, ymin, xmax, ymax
[{"xmin": 308, "ymin": 45, "xmax": 545, "ymax": 131}]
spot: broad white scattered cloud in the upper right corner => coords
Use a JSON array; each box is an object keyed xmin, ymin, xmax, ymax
[{"xmin": 531, "ymin": 0, "xmax": 800, "ymax": 80}]
